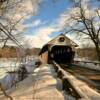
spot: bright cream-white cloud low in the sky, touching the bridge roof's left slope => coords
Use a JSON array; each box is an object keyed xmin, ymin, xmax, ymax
[{"xmin": 25, "ymin": 26, "xmax": 57, "ymax": 48}]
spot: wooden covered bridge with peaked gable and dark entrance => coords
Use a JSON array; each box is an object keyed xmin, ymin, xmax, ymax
[{"xmin": 39, "ymin": 34, "xmax": 78, "ymax": 63}]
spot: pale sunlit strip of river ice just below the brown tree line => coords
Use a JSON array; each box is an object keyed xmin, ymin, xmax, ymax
[{"xmin": 0, "ymin": 56, "xmax": 38, "ymax": 79}]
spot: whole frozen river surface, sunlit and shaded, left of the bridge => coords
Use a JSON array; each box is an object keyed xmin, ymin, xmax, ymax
[{"xmin": 0, "ymin": 56, "xmax": 38, "ymax": 89}]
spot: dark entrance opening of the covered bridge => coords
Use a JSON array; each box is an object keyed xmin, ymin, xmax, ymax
[{"xmin": 50, "ymin": 46, "xmax": 74, "ymax": 64}]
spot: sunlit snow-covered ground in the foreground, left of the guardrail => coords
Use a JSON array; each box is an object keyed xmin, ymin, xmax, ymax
[{"xmin": 0, "ymin": 65, "xmax": 64, "ymax": 100}]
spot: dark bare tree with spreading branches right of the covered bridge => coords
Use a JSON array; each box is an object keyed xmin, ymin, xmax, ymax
[{"xmin": 66, "ymin": 1, "xmax": 100, "ymax": 61}]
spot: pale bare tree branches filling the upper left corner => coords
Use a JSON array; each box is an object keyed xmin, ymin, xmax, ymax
[{"xmin": 0, "ymin": 0, "xmax": 37, "ymax": 47}]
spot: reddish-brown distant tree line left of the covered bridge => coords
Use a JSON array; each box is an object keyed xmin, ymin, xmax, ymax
[{"xmin": 0, "ymin": 46, "xmax": 40, "ymax": 58}]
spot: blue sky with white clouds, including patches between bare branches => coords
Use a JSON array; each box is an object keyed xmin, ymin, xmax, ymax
[{"xmin": 18, "ymin": 0, "xmax": 100, "ymax": 48}]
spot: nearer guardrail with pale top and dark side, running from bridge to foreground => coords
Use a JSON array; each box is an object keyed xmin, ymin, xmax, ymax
[{"xmin": 53, "ymin": 61, "xmax": 89, "ymax": 100}]
